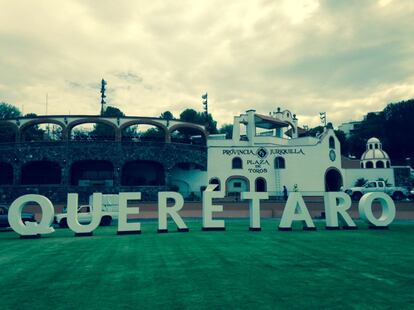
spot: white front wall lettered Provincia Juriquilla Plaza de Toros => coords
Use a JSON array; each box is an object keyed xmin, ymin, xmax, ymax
[{"xmin": 207, "ymin": 130, "xmax": 341, "ymax": 195}]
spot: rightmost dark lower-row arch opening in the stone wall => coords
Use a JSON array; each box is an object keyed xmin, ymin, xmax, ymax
[{"xmin": 121, "ymin": 160, "xmax": 165, "ymax": 186}]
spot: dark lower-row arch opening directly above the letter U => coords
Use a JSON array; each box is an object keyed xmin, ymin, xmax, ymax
[{"xmin": 70, "ymin": 160, "xmax": 114, "ymax": 186}]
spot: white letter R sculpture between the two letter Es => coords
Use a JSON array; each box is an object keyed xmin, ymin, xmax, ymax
[{"xmin": 158, "ymin": 192, "xmax": 189, "ymax": 233}]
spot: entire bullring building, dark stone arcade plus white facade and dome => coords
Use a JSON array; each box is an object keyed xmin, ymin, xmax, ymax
[{"xmin": 0, "ymin": 109, "xmax": 394, "ymax": 203}]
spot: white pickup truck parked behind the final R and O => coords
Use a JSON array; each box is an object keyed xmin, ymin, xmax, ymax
[{"xmin": 345, "ymin": 181, "xmax": 410, "ymax": 200}]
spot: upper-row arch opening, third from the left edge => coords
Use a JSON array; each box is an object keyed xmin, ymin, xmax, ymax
[{"xmin": 67, "ymin": 117, "xmax": 120, "ymax": 141}]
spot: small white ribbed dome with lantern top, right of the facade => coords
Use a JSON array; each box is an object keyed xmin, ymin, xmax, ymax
[{"xmin": 361, "ymin": 137, "xmax": 390, "ymax": 168}]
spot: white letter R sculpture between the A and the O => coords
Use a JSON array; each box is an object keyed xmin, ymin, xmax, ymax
[{"xmin": 324, "ymin": 192, "xmax": 357, "ymax": 229}]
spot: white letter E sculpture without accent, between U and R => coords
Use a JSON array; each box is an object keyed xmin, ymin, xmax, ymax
[{"xmin": 117, "ymin": 192, "xmax": 141, "ymax": 235}]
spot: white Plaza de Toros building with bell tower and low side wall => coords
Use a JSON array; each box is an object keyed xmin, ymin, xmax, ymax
[{"xmin": 207, "ymin": 109, "xmax": 394, "ymax": 196}]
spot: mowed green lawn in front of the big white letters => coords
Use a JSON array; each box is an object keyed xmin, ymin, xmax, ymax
[{"xmin": 0, "ymin": 220, "xmax": 414, "ymax": 309}]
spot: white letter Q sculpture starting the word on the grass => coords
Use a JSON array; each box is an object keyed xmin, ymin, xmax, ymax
[{"xmin": 8, "ymin": 194, "xmax": 55, "ymax": 238}]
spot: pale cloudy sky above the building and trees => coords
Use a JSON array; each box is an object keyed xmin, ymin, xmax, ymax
[{"xmin": 0, "ymin": 0, "xmax": 414, "ymax": 126}]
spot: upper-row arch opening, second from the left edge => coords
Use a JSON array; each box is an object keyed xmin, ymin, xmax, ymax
[{"xmin": 19, "ymin": 118, "xmax": 67, "ymax": 142}]
